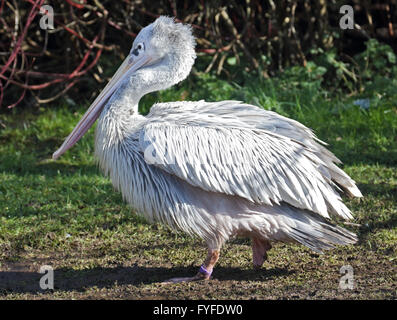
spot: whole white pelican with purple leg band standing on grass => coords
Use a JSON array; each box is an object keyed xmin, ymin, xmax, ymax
[{"xmin": 53, "ymin": 16, "xmax": 362, "ymax": 282}]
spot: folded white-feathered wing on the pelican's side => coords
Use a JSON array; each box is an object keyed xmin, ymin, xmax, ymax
[{"xmin": 139, "ymin": 101, "xmax": 358, "ymax": 218}]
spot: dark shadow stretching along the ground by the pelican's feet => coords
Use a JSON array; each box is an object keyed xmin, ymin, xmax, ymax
[{"xmin": 0, "ymin": 265, "xmax": 295, "ymax": 296}]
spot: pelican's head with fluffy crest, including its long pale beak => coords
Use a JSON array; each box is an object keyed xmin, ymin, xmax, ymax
[{"xmin": 52, "ymin": 16, "xmax": 196, "ymax": 160}]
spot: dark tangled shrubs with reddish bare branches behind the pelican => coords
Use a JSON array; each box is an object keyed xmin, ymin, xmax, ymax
[{"xmin": 0, "ymin": 0, "xmax": 397, "ymax": 109}]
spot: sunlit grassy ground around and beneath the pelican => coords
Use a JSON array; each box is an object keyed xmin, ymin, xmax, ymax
[{"xmin": 0, "ymin": 69, "xmax": 397, "ymax": 299}]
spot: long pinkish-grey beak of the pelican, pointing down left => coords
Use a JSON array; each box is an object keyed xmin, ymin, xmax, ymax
[{"xmin": 52, "ymin": 56, "xmax": 150, "ymax": 160}]
